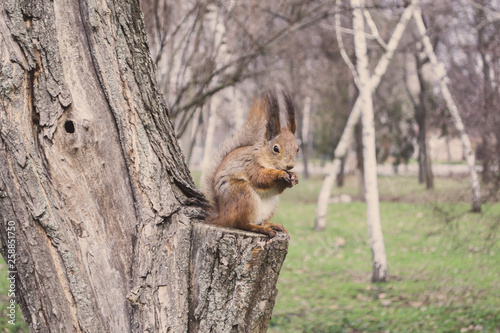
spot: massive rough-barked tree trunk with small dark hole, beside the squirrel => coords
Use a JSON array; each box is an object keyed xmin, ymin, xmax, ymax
[{"xmin": 0, "ymin": 0, "xmax": 287, "ymax": 332}]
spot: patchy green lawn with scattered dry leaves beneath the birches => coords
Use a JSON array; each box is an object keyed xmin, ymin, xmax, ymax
[{"xmin": 0, "ymin": 175, "xmax": 500, "ymax": 333}]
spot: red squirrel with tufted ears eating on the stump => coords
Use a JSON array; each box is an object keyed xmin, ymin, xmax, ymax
[{"xmin": 201, "ymin": 92, "xmax": 299, "ymax": 238}]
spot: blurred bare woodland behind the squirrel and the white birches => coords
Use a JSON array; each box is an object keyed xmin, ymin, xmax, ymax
[{"xmin": 141, "ymin": 0, "xmax": 500, "ymax": 195}]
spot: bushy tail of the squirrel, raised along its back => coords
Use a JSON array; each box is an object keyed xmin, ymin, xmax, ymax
[{"xmin": 201, "ymin": 92, "xmax": 279, "ymax": 208}]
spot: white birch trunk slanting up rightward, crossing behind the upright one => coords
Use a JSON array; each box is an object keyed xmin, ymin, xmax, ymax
[{"xmin": 314, "ymin": 0, "xmax": 416, "ymax": 230}]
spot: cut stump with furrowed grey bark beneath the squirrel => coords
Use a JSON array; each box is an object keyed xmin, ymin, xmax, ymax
[{"xmin": 189, "ymin": 223, "xmax": 288, "ymax": 332}]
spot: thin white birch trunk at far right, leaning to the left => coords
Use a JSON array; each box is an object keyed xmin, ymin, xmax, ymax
[{"xmin": 413, "ymin": 8, "xmax": 481, "ymax": 212}]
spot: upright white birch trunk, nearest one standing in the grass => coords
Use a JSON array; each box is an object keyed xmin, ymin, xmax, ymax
[{"xmin": 351, "ymin": 0, "xmax": 387, "ymax": 282}]
